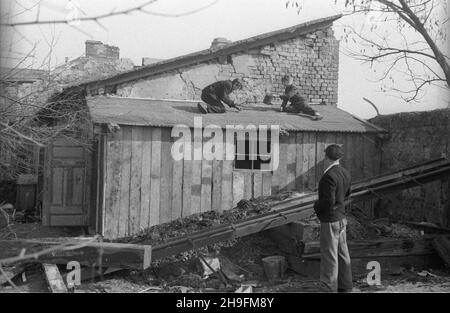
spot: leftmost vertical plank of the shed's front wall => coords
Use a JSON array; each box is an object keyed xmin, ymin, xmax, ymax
[{"xmin": 103, "ymin": 130, "xmax": 123, "ymax": 238}]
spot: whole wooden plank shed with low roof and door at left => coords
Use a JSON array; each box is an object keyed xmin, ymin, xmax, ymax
[{"xmin": 44, "ymin": 96, "xmax": 384, "ymax": 238}]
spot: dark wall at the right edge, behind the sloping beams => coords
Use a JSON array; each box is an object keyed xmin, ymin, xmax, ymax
[{"xmin": 371, "ymin": 109, "xmax": 450, "ymax": 226}]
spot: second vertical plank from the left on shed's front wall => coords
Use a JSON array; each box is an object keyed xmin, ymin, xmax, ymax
[{"xmin": 118, "ymin": 126, "xmax": 132, "ymax": 237}]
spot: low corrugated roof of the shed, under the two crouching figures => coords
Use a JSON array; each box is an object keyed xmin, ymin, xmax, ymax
[{"xmin": 87, "ymin": 96, "xmax": 384, "ymax": 133}]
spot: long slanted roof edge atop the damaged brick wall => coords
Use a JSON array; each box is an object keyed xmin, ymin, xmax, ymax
[{"xmin": 68, "ymin": 14, "xmax": 342, "ymax": 88}]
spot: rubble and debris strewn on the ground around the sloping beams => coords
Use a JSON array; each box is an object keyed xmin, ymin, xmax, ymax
[{"xmin": 0, "ymin": 188, "xmax": 450, "ymax": 293}]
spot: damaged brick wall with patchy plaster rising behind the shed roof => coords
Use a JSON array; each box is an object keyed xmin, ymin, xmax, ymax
[{"xmin": 117, "ymin": 27, "xmax": 339, "ymax": 105}]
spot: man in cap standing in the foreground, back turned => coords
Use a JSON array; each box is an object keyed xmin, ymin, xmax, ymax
[{"xmin": 314, "ymin": 144, "xmax": 353, "ymax": 292}]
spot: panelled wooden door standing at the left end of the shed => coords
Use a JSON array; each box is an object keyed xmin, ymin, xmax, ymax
[{"xmin": 42, "ymin": 139, "xmax": 90, "ymax": 226}]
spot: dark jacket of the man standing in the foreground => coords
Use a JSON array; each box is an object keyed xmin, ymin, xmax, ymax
[{"xmin": 314, "ymin": 165, "xmax": 351, "ymax": 223}]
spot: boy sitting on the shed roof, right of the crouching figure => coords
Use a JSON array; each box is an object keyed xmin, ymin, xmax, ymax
[{"xmin": 280, "ymin": 75, "xmax": 323, "ymax": 120}]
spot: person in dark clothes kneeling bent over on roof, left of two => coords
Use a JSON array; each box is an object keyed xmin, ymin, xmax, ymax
[{"xmin": 197, "ymin": 79, "xmax": 242, "ymax": 114}]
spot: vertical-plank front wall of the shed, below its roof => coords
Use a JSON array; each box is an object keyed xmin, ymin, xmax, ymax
[{"xmin": 103, "ymin": 126, "xmax": 381, "ymax": 238}]
